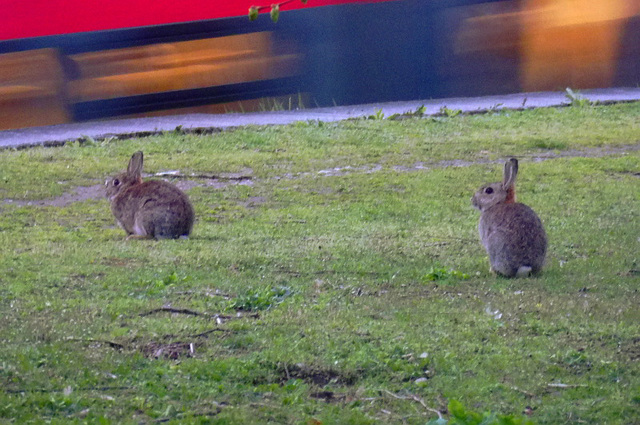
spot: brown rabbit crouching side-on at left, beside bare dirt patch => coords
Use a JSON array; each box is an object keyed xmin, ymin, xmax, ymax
[{"xmin": 106, "ymin": 151, "xmax": 195, "ymax": 239}]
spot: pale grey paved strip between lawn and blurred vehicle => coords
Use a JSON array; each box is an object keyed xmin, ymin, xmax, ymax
[{"xmin": 0, "ymin": 88, "xmax": 640, "ymax": 149}]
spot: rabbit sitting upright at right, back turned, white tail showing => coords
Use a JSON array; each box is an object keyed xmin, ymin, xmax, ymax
[{"xmin": 471, "ymin": 158, "xmax": 547, "ymax": 277}]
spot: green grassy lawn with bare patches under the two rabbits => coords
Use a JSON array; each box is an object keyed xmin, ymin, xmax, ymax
[{"xmin": 0, "ymin": 103, "xmax": 640, "ymax": 425}]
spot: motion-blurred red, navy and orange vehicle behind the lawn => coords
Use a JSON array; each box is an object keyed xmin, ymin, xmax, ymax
[{"xmin": 0, "ymin": 0, "xmax": 640, "ymax": 129}]
